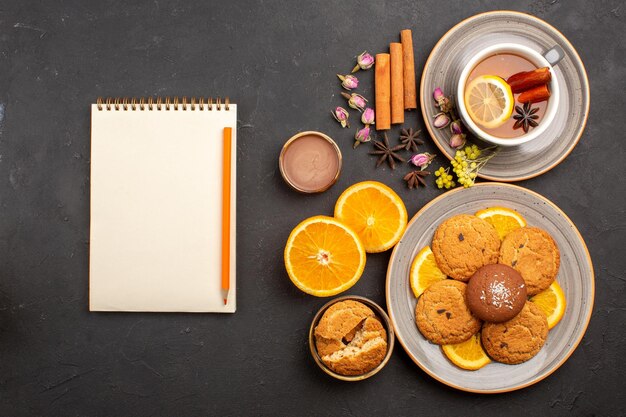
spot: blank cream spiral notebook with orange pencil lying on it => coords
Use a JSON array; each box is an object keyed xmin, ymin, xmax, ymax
[{"xmin": 89, "ymin": 98, "xmax": 237, "ymax": 313}]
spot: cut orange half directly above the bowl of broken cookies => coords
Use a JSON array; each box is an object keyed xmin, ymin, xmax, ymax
[{"xmin": 284, "ymin": 216, "xmax": 365, "ymax": 297}]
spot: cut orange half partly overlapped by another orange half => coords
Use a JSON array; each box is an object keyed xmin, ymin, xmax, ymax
[{"xmin": 335, "ymin": 181, "xmax": 408, "ymax": 253}]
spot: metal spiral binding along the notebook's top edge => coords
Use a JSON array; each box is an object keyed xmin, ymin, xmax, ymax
[{"xmin": 96, "ymin": 97, "xmax": 230, "ymax": 111}]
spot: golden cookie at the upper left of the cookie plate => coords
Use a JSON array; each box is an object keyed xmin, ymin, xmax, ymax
[{"xmin": 432, "ymin": 214, "xmax": 500, "ymax": 281}]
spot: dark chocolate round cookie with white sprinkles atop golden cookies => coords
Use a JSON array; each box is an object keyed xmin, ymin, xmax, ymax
[{"xmin": 466, "ymin": 264, "xmax": 527, "ymax": 323}]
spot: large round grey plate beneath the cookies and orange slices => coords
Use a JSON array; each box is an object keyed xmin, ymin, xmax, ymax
[{"xmin": 386, "ymin": 183, "xmax": 594, "ymax": 393}]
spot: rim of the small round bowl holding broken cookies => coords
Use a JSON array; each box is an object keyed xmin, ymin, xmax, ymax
[{"xmin": 309, "ymin": 295, "xmax": 395, "ymax": 382}]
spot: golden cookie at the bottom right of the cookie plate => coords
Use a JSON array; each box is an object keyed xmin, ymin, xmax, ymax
[{"xmin": 481, "ymin": 301, "xmax": 548, "ymax": 365}]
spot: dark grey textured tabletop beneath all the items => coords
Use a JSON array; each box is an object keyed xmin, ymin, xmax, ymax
[{"xmin": 0, "ymin": 0, "xmax": 626, "ymax": 416}]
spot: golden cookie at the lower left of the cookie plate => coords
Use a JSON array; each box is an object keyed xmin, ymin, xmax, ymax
[{"xmin": 415, "ymin": 279, "xmax": 481, "ymax": 345}]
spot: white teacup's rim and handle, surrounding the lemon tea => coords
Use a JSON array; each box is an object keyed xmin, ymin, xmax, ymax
[{"xmin": 456, "ymin": 43, "xmax": 564, "ymax": 146}]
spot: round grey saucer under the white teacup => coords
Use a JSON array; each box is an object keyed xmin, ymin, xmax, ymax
[{"xmin": 420, "ymin": 11, "xmax": 589, "ymax": 182}]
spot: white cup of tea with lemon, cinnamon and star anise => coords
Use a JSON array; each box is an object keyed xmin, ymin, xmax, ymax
[{"xmin": 457, "ymin": 43, "xmax": 563, "ymax": 146}]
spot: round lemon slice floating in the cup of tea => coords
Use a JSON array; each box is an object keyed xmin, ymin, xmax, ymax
[{"xmin": 465, "ymin": 75, "xmax": 515, "ymax": 129}]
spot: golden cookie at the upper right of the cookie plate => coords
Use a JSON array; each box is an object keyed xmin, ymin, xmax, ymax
[{"xmin": 499, "ymin": 227, "xmax": 561, "ymax": 295}]
